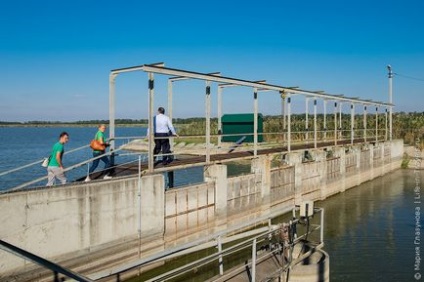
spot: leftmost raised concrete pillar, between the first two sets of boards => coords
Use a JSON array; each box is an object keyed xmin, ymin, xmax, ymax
[{"xmin": 204, "ymin": 164, "xmax": 228, "ymax": 217}]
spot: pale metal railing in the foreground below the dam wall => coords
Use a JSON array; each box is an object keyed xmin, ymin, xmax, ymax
[{"xmin": 90, "ymin": 206, "xmax": 324, "ymax": 282}]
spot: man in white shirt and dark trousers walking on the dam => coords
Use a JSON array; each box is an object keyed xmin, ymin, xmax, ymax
[{"xmin": 153, "ymin": 107, "xmax": 178, "ymax": 165}]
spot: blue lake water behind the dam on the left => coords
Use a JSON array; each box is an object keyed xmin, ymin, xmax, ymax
[{"xmin": 0, "ymin": 127, "xmax": 210, "ymax": 191}]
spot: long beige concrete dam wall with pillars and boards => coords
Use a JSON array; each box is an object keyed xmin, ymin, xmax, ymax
[{"xmin": 0, "ymin": 140, "xmax": 403, "ymax": 281}]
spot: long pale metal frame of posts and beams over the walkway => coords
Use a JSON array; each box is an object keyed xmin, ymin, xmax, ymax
[{"xmin": 109, "ymin": 63, "xmax": 393, "ymax": 173}]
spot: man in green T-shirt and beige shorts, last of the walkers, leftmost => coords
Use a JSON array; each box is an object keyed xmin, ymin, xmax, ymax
[{"xmin": 46, "ymin": 131, "xmax": 69, "ymax": 186}]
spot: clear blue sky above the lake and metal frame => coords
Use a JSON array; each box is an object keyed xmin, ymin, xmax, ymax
[{"xmin": 0, "ymin": 0, "xmax": 424, "ymax": 121}]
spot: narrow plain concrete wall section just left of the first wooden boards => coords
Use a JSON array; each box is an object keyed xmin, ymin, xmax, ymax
[{"xmin": 140, "ymin": 174, "xmax": 165, "ymax": 236}]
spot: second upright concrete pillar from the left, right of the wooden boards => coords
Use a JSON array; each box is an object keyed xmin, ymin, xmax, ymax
[{"xmin": 251, "ymin": 156, "xmax": 271, "ymax": 204}]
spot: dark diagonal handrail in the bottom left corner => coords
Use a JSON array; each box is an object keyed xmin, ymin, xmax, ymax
[{"xmin": 0, "ymin": 240, "xmax": 94, "ymax": 282}]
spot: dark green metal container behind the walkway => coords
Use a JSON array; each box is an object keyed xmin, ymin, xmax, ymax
[{"xmin": 221, "ymin": 114, "xmax": 263, "ymax": 142}]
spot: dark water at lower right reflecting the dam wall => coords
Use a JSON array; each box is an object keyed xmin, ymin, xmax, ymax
[{"xmin": 317, "ymin": 170, "xmax": 424, "ymax": 281}]
